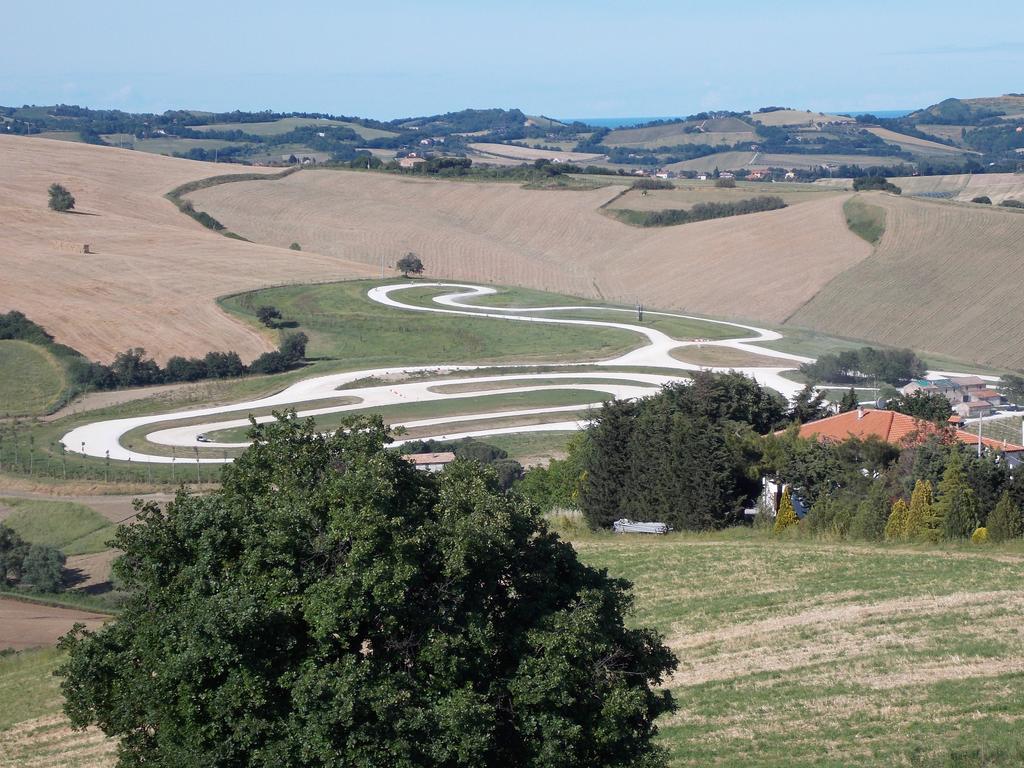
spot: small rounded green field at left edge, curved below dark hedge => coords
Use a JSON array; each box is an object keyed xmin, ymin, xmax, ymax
[{"xmin": 0, "ymin": 340, "xmax": 67, "ymax": 417}]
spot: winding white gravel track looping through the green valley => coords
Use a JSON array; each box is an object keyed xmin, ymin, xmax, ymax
[{"xmin": 62, "ymin": 282, "xmax": 831, "ymax": 464}]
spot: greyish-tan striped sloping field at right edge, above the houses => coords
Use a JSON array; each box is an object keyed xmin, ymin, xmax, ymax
[{"xmin": 790, "ymin": 194, "xmax": 1024, "ymax": 368}]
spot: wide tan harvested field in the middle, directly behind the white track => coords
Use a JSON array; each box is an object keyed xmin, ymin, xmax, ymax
[{"xmin": 189, "ymin": 171, "xmax": 871, "ymax": 322}]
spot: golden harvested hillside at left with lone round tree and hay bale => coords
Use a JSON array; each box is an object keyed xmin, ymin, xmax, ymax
[{"xmin": 0, "ymin": 136, "xmax": 369, "ymax": 360}]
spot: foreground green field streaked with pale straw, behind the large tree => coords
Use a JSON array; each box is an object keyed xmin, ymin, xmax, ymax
[{"xmin": 0, "ymin": 524, "xmax": 1024, "ymax": 768}]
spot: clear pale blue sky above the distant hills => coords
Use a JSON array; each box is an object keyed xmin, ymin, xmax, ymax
[{"xmin": 0, "ymin": 0, "xmax": 1024, "ymax": 119}]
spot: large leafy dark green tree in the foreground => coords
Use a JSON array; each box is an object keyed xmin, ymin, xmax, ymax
[{"xmin": 61, "ymin": 417, "xmax": 675, "ymax": 768}]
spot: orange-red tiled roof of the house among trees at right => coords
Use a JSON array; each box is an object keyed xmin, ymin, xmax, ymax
[{"xmin": 786, "ymin": 408, "xmax": 1024, "ymax": 453}]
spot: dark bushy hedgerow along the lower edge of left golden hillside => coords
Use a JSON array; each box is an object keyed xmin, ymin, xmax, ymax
[{"xmin": 0, "ymin": 310, "xmax": 309, "ymax": 395}]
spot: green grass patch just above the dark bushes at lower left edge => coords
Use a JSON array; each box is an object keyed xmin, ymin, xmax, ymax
[{"xmin": 0, "ymin": 499, "xmax": 117, "ymax": 555}]
